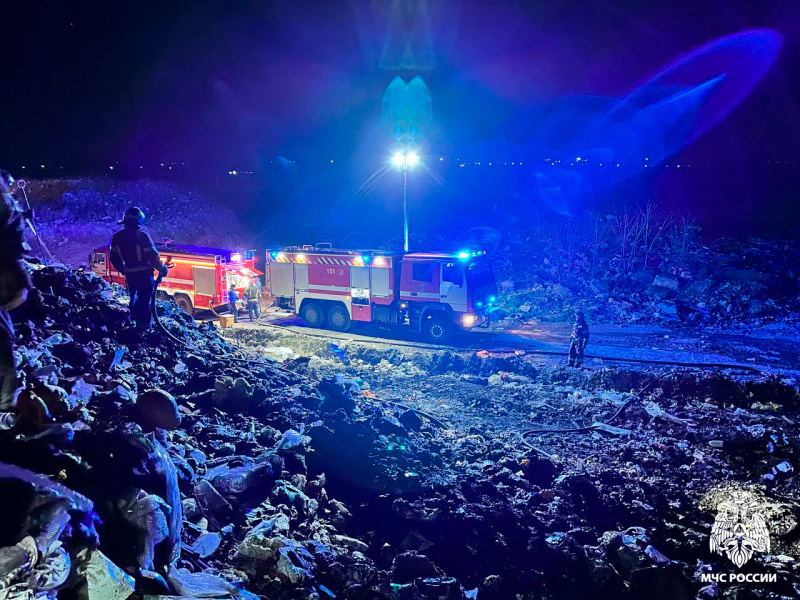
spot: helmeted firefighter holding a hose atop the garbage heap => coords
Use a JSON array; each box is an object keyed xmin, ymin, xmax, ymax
[{"xmin": 109, "ymin": 206, "xmax": 167, "ymax": 330}]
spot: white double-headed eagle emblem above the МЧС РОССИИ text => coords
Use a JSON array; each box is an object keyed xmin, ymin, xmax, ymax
[{"xmin": 709, "ymin": 494, "xmax": 769, "ymax": 567}]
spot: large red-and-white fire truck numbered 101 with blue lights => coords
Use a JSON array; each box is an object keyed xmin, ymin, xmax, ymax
[{"xmin": 267, "ymin": 244, "xmax": 496, "ymax": 342}]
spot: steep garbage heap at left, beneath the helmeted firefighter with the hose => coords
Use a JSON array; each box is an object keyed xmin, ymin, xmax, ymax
[{"xmin": 0, "ymin": 267, "xmax": 424, "ymax": 600}]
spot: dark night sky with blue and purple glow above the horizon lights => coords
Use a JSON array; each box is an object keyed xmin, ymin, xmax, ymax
[{"xmin": 0, "ymin": 0, "xmax": 800, "ymax": 240}]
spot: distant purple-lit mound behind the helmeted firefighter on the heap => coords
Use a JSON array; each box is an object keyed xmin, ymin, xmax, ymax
[{"xmin": 28, "ymin": 179, "xmax": 252, "ymax": 267}]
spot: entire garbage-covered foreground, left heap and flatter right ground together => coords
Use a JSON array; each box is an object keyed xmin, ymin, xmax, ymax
[{"xmin": 0, "ymin": 267, "xmax": 800, "ymax": 600}]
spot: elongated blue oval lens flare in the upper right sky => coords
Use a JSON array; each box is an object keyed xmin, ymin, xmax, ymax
[{"xmin": 533, "ymin": 29, "xmax": 781, "ymax": 214}]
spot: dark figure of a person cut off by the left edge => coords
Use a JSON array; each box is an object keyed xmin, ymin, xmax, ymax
[{"xmin": 0, "ymin": 171, "xmax": 33, "ymax": 414}]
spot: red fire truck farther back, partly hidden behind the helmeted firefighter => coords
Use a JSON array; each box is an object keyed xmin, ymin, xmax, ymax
[{"xmin": 89, "ymin": 242, "xmax": 262, "ymax": 313}]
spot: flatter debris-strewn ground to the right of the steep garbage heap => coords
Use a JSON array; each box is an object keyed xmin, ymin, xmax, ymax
[{"xmin": 232, "ymin": 330, "xmax": 800, "ymax": 599}]
